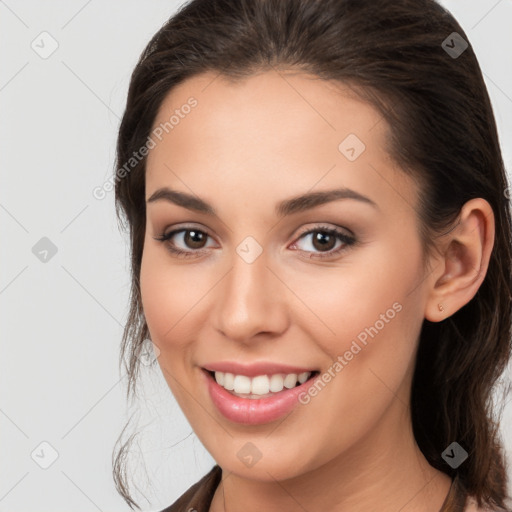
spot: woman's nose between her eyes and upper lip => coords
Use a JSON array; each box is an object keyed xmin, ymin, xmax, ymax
[{"xmin": 213, "ymin": 247, "xmax": 289, "ymax": 343}]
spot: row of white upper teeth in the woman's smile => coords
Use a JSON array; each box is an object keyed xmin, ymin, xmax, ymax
[{"xmin": 211, "ymin": 372, "xmax": 311, "ymax": 396}]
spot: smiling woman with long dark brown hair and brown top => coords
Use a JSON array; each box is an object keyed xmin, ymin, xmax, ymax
[{"xmin": 114, "ymin": 0, "xmax": 512, "ymax": 512}]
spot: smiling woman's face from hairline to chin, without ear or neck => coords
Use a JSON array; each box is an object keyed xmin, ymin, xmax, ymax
[{"xmin": 140, "ymin": 71, "xmax": 431, "ymax": 480}]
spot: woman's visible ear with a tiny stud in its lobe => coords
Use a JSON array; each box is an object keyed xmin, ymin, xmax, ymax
[{"xmin": 425, "ymin": 198, "xmax": 495, "ymax": 322}]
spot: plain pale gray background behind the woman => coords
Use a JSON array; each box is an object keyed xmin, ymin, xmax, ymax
[{"xmin": 0, "ymin": 0, "xmax": 512, "ymax": 512}]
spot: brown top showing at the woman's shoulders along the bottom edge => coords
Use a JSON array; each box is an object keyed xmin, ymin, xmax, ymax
[{"xmin": 161, "ymin": 464, "xmax": 487, "ymax": 512}]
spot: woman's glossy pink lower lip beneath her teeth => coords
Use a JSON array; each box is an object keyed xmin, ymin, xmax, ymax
[{"xmin": 202, "ymin": 370, "xmax": 318, "ymax": 425}]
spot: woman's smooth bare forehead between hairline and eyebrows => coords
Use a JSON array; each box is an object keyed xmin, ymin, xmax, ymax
[{"xmin": 146, "ymin": 70, "xmax": 413, "ymax": 218}]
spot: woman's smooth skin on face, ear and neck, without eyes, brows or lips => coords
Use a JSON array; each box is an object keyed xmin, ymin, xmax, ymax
[{"xmin": 140, "ymin": 70, "xmax": 494, "ymax": 512}]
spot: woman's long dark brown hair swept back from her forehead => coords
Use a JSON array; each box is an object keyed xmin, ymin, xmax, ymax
[{"xmin": 113, "ymin": 0, "xmax": 512, "ymax": 509}]
